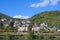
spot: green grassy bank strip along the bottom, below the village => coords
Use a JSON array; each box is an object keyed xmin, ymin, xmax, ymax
[{"xmin": 0, "ymin": 32, "xmax": 60, "ymax": 40}]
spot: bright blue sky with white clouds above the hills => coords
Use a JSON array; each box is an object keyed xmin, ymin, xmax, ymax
[{"xmin": 0, "ymin": 0, "xmax": 60, "ymax": 19}]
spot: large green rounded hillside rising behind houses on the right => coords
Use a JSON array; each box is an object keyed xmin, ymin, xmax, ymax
[{"xmin": 30, "ymin": 11, "xmax": 60, "ymax": 26}]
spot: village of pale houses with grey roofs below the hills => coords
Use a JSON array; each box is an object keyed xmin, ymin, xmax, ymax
[{"xmin": 0, "ymin": 18, "xmax": 60, "ymax": 32}]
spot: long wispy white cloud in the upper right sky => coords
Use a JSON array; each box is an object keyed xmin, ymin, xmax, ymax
[{"xmin": 30, "ymin": 0, "xmax": 59, "ymax": 8}]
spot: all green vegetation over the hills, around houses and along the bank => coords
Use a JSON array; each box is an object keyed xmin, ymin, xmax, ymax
[{"xmin": 0, "ymin": 11, "xmax": 60, "ymax": 40}]
